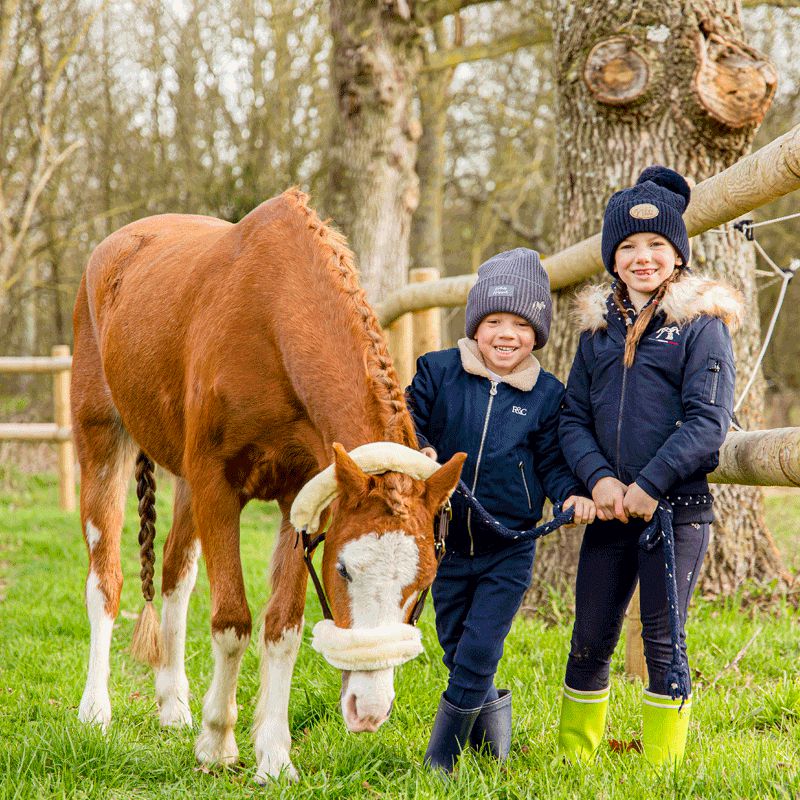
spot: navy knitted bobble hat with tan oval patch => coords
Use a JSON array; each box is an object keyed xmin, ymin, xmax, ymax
[{"xmin": 601, "ymin": 166, "xmax": 691, "ymax": 275}]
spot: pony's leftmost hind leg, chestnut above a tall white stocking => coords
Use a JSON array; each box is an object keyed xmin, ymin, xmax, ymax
[{"xmin": 76, "ymin": 406, "xmax": 135, "ymax": 729}]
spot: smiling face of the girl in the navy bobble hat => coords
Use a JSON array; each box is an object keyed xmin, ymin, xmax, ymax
[{"xmin": 614, "ymin": 233, "xmax": 683, "ymax": 311}]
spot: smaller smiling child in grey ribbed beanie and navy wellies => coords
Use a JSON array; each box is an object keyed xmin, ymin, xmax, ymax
[{"xmin": 408, "ymin": 247, "xmax": 594, "ymax": 772}]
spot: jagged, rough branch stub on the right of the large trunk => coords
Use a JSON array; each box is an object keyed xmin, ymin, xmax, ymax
[{"xmin": 692, "ymin": 33, "xmax": 778, "ymax": 129}]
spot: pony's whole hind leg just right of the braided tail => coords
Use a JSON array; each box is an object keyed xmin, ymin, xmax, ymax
[{"xmin": 156, "ymin": 478, "xmax": 200, "ymax": 727}]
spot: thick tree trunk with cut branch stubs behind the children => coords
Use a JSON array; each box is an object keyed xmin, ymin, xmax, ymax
[{"xmin": 526, "ymin": 0, "xmax": 782, "ymax": 606}]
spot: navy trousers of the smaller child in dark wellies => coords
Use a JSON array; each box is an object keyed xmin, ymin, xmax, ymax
[{"xmin": 431, "ymin": 540, "xmax": 536, "ymax": 709}]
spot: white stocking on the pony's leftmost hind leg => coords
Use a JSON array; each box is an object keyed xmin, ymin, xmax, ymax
[{"xmin": 78, "ymin": 568, "xmax": 114, "ymax": 730}]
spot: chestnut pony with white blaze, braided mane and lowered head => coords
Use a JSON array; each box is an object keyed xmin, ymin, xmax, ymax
[{"xmin": 72, "ymin": 189, "xmax": 463, "ymax": 781}]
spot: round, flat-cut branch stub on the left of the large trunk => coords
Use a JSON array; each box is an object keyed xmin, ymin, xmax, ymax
[{"xmin": 583, "ymin": 36, "xmax": 650, "ymax": 105}]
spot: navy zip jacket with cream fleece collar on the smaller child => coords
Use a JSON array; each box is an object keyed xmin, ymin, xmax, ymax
[{"xmin": 407, "ymin": 339, "xmax": 586, "ymax": 554}]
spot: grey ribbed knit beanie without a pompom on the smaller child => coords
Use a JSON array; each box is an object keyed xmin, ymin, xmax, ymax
[{"xmin": 466, "ymin": 247, "xmax": 553, "ymax": 350}]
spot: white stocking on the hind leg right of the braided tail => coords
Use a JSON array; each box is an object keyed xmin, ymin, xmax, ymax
[{"xmin": 156, "ymin": 541, "xmax": 200, "ymax": 728}]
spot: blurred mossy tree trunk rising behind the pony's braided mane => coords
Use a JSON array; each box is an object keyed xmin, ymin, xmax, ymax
[{"xmin": 326, "ymin": 0, "xmax": 421, "ymax": 302}]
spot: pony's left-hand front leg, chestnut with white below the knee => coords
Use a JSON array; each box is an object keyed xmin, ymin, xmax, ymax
[{"xmin": 192, "ymin": 478, "xmax": 252, "ymax": 764}]
